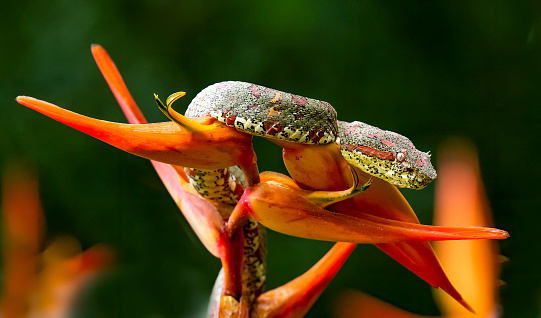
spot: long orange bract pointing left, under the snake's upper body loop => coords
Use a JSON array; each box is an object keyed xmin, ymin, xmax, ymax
[{"xmin": 17, "ymin": 96, "xmax": 253, "ymax": 169}]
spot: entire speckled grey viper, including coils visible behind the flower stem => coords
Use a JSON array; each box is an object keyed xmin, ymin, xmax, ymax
[{"xmin": 159, "ymin": 81, "xmax": 436, "ymax": 312}]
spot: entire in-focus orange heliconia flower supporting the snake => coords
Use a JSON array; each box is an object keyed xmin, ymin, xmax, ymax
[{"xmin": 17, "ymin": 45, "xmax": 508, "ymax": 317}]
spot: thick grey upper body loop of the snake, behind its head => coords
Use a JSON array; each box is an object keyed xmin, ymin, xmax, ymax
[{"xmin": 185, "ymin": 82, "xmax": 338, "ymax": 144}]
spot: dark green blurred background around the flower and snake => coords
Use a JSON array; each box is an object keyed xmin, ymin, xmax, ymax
[{"xmin": 0, "ymin": 0, "xmax": 541, "ymax": 317}]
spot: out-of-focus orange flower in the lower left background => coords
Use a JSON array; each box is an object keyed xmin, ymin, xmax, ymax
[{"xmin": 0, "ymin": 167, "xmax": 113, "ymax": 318}]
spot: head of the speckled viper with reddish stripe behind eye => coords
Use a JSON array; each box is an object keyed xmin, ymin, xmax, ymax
[{"xmin": 338, "ymin": 121, "xmax": 437, "ymax": 189}]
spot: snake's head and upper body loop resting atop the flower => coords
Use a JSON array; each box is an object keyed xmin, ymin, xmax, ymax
[{"xmin": 158, "ymin": 81, "xmax": 436, "ymax": 189}]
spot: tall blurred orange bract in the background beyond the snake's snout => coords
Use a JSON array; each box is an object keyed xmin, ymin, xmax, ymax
[{"xmin": 435, "ymin": 141, "xmax": 499, "ymax": 317}]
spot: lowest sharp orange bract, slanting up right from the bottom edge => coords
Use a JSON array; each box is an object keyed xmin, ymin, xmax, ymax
[{"xmin": 252, "ymin": 243, "xmax": 356, "ymax": 318}]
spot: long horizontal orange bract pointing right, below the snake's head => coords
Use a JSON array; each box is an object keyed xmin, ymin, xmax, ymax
[{"xmin": 247, "ymin": 173, "xmax": 507, "ymax": 244}]
